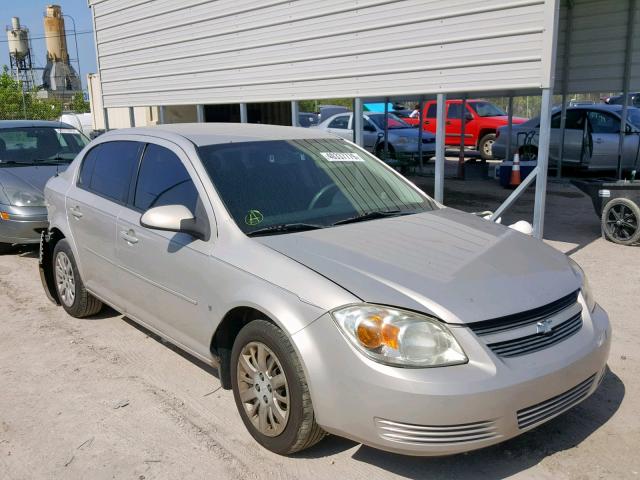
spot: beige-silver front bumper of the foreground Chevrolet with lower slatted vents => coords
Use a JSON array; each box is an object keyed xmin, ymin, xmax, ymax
[{"xmin": 293, "ymin": 306, "xmax": 611, "ymax": 455}]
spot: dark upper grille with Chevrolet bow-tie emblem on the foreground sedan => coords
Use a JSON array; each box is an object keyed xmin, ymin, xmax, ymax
[{"xmin": 469, "ymin": 291, "xmax": 582, "ymax": 358}]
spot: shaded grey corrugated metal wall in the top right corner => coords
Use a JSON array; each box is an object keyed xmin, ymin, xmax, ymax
[{"xmin": 555, "ymin": 0, "xmax": 640, "ymax": 93}]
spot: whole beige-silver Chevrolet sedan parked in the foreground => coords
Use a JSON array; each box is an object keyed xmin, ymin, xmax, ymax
[{"xmin": 40, "ymin": 124, "xmax": 611, "ymax": 455}]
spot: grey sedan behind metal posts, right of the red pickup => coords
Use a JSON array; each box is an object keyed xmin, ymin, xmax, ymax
[{"xmin": 493, "ymin": 104, "xmax": 640, "ymax": 170}]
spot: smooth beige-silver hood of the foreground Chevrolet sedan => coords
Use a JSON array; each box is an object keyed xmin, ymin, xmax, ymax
[{"xmin": 256, "ymin": 208, "xmax": 580, "ymax": 323}]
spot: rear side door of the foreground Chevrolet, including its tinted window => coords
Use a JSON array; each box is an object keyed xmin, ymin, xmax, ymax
[{"xmin": 66, "ymin": 141, "xmax": 142, "ymax": 307}]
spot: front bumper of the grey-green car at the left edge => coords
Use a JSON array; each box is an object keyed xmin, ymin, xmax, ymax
[{"xmin": 0, "ymin": 205, "xmax": 49, "ymax": 244}]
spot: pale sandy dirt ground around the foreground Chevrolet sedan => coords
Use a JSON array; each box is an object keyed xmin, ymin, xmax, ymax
[{"xmin": 0, "ymin": 161, "xmax": 640, "ymax": 480}]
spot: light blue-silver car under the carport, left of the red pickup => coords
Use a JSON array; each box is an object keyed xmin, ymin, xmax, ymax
[{"xmin": 315, "ymin": 113, "xmax": 436, "ymax": 166}]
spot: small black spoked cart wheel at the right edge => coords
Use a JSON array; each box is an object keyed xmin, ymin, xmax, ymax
[{"xmin": 601, "ymin": 198, "xmax": 640, "ymax": 245}]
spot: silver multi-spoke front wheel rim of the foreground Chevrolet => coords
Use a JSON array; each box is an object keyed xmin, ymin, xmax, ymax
[{"xmin": 237, "ymin": 342, "xmax": 290, "ymax": 437}]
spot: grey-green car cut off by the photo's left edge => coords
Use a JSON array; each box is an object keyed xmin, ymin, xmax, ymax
[{"xmin": 0, "ymin": 120, "xmax": 89, "ymax": 253}]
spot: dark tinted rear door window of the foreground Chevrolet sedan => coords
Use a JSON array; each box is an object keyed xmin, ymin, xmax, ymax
[{"xmin": 89, "ymin": 141, "xmax": 141, "ymax": 202}]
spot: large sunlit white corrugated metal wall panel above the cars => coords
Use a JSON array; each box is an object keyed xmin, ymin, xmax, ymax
[{"xmin": 90, "ymin": 0, "xmax": 556, "ymax": 107}]
